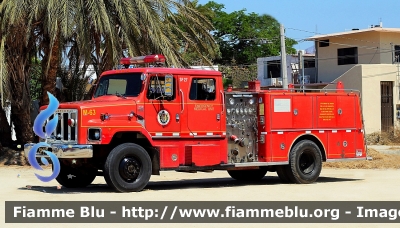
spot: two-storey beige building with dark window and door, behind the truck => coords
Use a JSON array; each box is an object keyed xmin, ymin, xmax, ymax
[{"xmin": 309, "ymin": 26, "xmax": 400, "ymax": 134}]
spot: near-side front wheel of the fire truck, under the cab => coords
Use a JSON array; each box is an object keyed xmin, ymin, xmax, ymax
[{"xmin": 104, "ymin": 143, "xmax": 152, "ymax": 192}]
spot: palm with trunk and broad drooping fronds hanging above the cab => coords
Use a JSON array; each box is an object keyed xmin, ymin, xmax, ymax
[{"xmin": 35, "ymin": 0, "xmax": 216, "ymax": 104}]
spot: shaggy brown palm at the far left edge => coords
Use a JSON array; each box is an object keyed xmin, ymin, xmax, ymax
[{"xmin": 0, "ymin": 0, "xmax": 40, "ymax": 143}]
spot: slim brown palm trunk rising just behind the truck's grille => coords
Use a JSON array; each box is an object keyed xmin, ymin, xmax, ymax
[{"xmin": 40, "ymin": 31, "xmax": 60, "ymax": 106}]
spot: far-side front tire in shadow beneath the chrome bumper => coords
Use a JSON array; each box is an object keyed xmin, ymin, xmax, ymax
[{"xmin": 56, "ymin": 162, "xmax": 97, "ymax": 188}]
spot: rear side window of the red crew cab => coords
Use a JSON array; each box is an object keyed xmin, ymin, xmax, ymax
[{"xmin": 189, "ymin": 78, "xmax": 215, "ymax": 101}]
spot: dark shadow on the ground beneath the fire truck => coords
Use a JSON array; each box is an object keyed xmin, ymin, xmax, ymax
[{"xmin": 18, "ymin": 176, "xmax": 362, "ymax": 194}]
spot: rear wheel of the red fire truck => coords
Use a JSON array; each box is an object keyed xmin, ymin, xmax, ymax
[{"xmin": 289, "ymin": 140, "xmax": 322, "ymax": 184}]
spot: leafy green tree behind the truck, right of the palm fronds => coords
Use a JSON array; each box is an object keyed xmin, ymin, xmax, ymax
[{"xmin": 197, "ymin": 1, "xmax": 296, "ymax": 64}]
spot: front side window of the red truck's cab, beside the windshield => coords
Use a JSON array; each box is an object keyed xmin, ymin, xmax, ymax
[{"xmin": 147, "ymin": 76, "xmax": 176, "ymax": 100}]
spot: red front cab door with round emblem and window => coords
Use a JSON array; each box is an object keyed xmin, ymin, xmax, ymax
[{"xmin": 144, "ymin": 74, "xmax": 181, "ymax": 139}]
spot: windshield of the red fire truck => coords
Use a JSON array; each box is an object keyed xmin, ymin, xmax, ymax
[{"xmin": 94, "ymin": 72, "xmax": 142, "ymax": 97}]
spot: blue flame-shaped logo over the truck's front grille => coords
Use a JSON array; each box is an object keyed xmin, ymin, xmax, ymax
[{"xmin": 28, "ymin": 92, "xmax": 60, "ymax": 182}]
